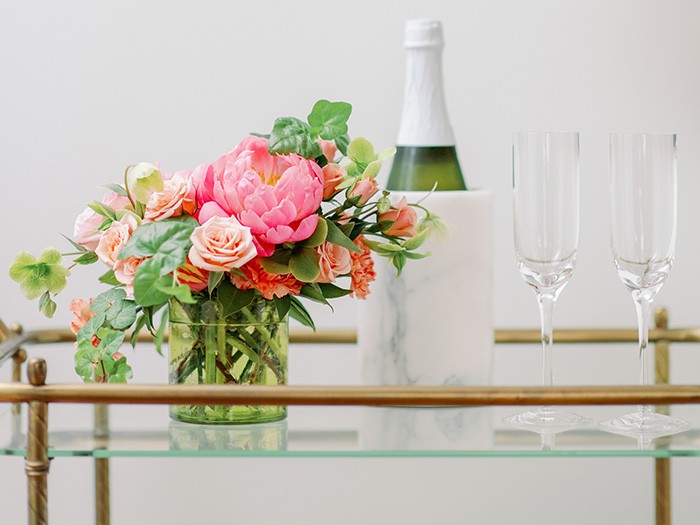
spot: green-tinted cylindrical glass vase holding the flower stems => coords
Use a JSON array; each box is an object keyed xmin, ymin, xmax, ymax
[{"xmin": 169, "ymin": 298, "xmax": 289, "ymax": 424}]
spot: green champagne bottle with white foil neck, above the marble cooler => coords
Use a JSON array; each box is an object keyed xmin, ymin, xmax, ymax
[{"xmin": 387, "ymin": 20, "xmax": 467, "ymax": 191}]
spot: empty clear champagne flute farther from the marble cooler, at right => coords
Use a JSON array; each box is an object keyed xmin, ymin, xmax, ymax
[{"xmin": 600, "ymin": 133, "xmax": 689, "ymax": 441}]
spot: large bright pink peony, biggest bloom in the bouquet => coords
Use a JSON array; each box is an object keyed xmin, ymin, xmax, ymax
[{"xmin": 193, "ymin": 137, "xmax": 323, "ymax": 257}]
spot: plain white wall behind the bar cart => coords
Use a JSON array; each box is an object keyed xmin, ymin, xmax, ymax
[{"xmin": 0, "ymin": 0, "xmax": 700, "ymax": 524}]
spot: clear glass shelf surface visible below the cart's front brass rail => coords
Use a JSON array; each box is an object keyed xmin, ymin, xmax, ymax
[{"xmin": 0, "ymin": 404, "xmax": 700, "ymax": 458}]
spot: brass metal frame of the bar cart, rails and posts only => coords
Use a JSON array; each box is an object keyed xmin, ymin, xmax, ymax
[{"xmin": 0, "ymin": 309, "xmax": 700, "ymax": 525}]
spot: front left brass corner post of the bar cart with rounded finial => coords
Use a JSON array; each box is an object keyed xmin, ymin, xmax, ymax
[{"xmin": 24, "ymin": 358, "xmax": 49, "ymax": 525}]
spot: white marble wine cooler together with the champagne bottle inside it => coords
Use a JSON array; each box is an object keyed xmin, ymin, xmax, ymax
[{"xmin": 358, "ymin": 20, "xmax": 493, "ymax": 385}]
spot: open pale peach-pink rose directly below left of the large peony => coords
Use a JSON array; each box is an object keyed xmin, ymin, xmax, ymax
[{"xmin": 189, "ymin": 217, "xmax": 257, "ymax": 272}]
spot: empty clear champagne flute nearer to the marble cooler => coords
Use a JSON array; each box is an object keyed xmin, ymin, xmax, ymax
[{"xmin": 505, "ymin": 132, "xmax": 590, "ymax": 434}]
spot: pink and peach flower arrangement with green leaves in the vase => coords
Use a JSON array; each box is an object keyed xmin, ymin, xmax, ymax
[{"xmin": 9, "ymin": 100, "xmax": 437, "ymax": 382}]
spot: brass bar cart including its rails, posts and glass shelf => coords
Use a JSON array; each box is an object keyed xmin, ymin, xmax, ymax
[{"xmin": 0, "ymin": 309, "xmax": 700, "ymax": 525}]
